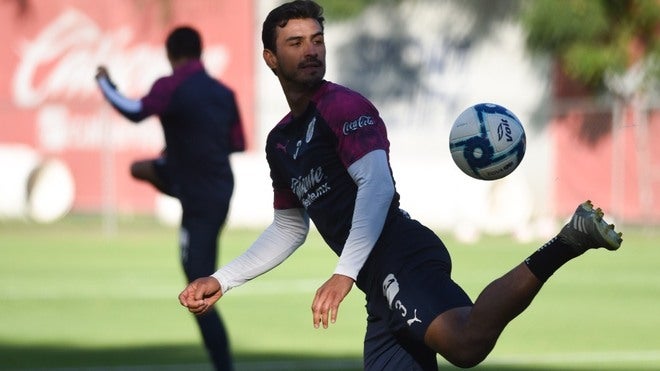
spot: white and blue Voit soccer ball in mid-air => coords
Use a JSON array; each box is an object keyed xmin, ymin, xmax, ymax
[{"xmin": 449, "ymin": 103, "xmax": 526, "ymax": 180}]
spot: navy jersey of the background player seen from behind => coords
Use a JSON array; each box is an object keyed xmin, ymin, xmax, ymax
[{"xmin": 141, "ymin": 60, "xmax": 245, "ymax": 208}]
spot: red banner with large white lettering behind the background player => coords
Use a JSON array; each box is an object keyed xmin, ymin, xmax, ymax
[{"xmin": 0, "ymin": 0, "xmax": 255, "ymax": 217}]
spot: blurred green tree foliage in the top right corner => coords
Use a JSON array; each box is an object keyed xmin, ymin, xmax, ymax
[{"xmin": 522, "ymin": 0, "xmax": 660, "ymax": 96}]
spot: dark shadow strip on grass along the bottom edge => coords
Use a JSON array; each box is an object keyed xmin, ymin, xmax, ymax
[{"xmin": 0, "ymin": 344, "xmax": 608, "ymax": 371}]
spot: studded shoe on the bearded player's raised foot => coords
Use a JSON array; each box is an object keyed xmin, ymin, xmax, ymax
[{"xmin": 559, "ymin": 201, "xmax": 623, "ymax": 254}]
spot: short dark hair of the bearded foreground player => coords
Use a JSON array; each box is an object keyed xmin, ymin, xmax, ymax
[{"xmin": 261, "ymin": 0, "xmax": 325, "ymax": 52}]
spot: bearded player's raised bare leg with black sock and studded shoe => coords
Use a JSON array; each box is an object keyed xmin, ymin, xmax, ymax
[{"xmin": 425, "ymin": 201, "xmax": 623, "ymax": 367}]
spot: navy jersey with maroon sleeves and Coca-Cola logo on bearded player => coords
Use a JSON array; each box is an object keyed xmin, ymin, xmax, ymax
[{"xmin": 266, "ymin": 81, "xmax": 399, "ymax": 255}]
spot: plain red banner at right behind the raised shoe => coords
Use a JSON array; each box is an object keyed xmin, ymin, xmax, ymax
[{"xmin": 551, "ymin": 109, "xmax": 660, "ymax": 225}]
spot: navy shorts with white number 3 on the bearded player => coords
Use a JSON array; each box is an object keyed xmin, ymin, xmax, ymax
[{"xmin": 358, "ymin": 215, "xmax": 472, "ymax": 371}]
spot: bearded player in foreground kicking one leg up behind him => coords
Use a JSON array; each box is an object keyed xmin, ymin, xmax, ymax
[{"xmin": 179, "ymin": 0, "xmax": 622, "ymax": 371}]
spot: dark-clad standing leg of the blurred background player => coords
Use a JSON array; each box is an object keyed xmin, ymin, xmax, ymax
[{"xmin": 180, "ymin": 210, "xmax": 233, "ymax": 371}]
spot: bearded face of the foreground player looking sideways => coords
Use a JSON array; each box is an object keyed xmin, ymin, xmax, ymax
[{"xmin": 266, "ymin": 18, "xmax": 325, "ymax": 85}]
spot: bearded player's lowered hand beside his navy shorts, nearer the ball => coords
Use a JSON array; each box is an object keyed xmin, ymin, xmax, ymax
[{"xmin": 312, "ymin": 274, "xmax": 353, "ymax": 328}]
